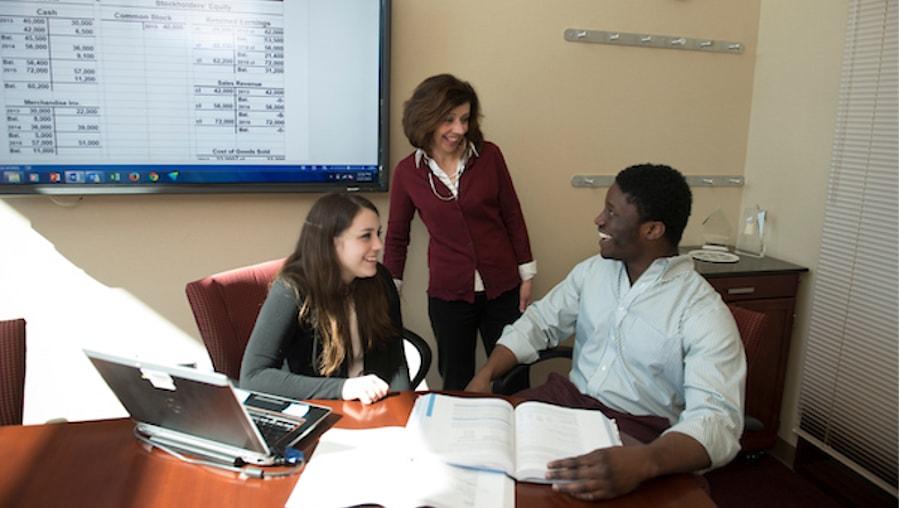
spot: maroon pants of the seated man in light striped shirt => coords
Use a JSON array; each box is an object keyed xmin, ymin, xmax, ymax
[{"xmin": 515, "ymin": 372, "xmax": 669, "ymax": 443}]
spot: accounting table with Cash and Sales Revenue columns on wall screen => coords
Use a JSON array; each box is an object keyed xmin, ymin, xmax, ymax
[{"xmin": 0, "ymin": 0, "xmax": 286, "ymax": 164}]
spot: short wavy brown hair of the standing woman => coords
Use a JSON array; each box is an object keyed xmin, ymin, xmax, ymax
[{"xmin": 403, "ymin": 74, "xmax": 484, "ymax": 155}]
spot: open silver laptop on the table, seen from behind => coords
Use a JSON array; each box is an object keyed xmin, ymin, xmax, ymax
[{"xmin": 84, "ymin": 350, "xmax": 331, "ymax": 465}]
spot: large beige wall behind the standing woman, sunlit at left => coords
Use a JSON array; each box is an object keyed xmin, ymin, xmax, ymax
[{"xmin": 0, "ymin": 0, "xmax": 768, "ymax": 421}]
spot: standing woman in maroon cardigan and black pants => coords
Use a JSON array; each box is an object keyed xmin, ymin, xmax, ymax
[{"xmin": 384, "ymin": 74, "xmax": 537, "ymax": 390}]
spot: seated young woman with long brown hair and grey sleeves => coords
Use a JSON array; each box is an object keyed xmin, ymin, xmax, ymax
[{"xmin": 240, "ymin": 194, "xmax": 410, "ymax": 404}]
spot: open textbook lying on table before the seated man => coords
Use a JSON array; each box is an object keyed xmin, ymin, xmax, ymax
[{"xmin": 406, "ymin": 393, "xmax": 622, "ymax": 483}]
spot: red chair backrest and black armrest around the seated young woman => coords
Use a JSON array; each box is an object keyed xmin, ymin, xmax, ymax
[{"xmin": 185, "ymin": 259, "xmax": 431, "ymax": 388}]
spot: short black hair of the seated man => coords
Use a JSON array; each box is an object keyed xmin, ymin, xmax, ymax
[{"xmin": 616, "ymin": 163, "xmax": 691, "ymax": 247}]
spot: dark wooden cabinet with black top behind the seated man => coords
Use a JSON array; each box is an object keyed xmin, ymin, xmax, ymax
[{"xmin": 685, "ymin": 248, "xmax": 807, "ymax": 451}]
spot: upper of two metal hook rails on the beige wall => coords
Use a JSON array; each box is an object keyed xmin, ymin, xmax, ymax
[{"xmin": 563, "ymin": 28, "xmax": 744, "ymax": 54}]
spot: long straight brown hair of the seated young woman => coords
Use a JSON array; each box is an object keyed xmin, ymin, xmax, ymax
[{"xmin": 281, "ymin": 193, "xmax": 400, "ymax": 376}]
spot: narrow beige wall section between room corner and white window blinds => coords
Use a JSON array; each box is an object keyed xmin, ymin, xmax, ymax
[{"xmin": 743, "ymin": 0, "xmax": 847, "ymax": 444}]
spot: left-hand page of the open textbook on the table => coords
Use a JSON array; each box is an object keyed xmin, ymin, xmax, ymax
[{"xmin": 406, "ymin": 393, "xmax": 515, "ymax": 476}]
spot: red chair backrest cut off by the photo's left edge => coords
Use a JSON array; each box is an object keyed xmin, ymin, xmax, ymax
[{"xmin": 0, "ymin": 319, "xmax": 25, "ymax": 425}]
